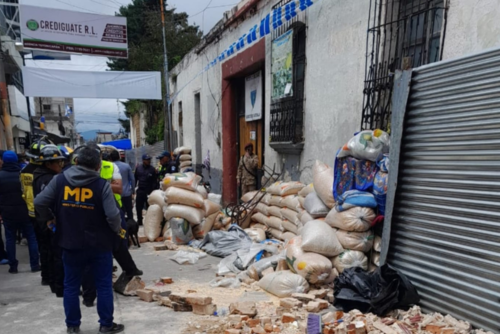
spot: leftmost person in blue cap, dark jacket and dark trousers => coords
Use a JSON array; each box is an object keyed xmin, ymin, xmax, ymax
[{"xmin": 0, "ymin": 151, "xmax": 40, "ymax": 274}]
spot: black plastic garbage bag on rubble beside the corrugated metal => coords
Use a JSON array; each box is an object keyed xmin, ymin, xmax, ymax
[{"xmin": 334, "ymin": 264, "xmax": 420, "ymax": 316}]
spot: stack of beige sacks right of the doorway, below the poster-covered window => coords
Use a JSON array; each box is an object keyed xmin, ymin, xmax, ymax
[{"xmin": 252, "ymin": 182, "xmax": 305, "ymax": 241}]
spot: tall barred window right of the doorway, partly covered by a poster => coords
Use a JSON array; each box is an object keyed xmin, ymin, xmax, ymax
[{"xmin": 269, "ymin": 0, "xmax": 306, "ymax": 147}]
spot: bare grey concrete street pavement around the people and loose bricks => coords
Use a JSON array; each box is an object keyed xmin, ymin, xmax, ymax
[{"xmin": 0, "ymin": 235, "xmax": 224, "ymax": 334}]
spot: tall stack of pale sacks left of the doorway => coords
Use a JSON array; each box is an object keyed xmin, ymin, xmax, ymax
[{"xmin": 162, "ymin": 173, "xmax": 215, "ymax": 245}]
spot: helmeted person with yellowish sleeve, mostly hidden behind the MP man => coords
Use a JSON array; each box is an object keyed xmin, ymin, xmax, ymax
[{"xmin": 21, "ymin": 140, "xmax": 50, "ymax": 274}]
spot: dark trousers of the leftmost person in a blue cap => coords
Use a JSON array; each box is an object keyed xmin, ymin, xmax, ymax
[{"xmin": 3, "ymin": 220, "xmax": 40, "ymax": 270}]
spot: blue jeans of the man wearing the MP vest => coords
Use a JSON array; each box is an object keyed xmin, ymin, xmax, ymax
[{"xmin": 63, "ymin": 249, "xmax": 114, "ymax": 327}]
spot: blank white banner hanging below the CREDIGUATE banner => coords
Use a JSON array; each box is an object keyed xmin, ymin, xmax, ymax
[{"xmin": 23, "ymin": 67, "xmax": 162, "ymax": 100}]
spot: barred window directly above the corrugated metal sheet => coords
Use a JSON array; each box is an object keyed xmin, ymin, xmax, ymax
[{"xmin": 361, "ymin": 0, "xmax": 448, "ymax": 132}]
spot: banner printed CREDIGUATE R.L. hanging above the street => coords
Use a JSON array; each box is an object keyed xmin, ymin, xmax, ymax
[{"xmin": 20, "ymin": 5, "xmax": 128, "ymax": 58}]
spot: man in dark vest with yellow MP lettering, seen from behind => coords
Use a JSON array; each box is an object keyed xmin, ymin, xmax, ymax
[{"xmin": 35, "ymin": 147, "xmax": 125, "ymax": 333}]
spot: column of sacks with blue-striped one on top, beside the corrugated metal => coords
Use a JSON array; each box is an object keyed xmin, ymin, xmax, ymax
[{"xmin": 325, "ymin": 190, "xmax": 377, "ymax": 273}]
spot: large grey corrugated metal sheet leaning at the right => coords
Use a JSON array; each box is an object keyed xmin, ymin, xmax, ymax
[{"xmin": 381, "ymin": 50, "xmax": 500, "ymax": 333}]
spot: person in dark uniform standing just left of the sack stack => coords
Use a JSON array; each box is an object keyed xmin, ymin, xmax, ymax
[{"xmin": 134, "ymin": 154, "xmax": 158, "ymax": 225}]
